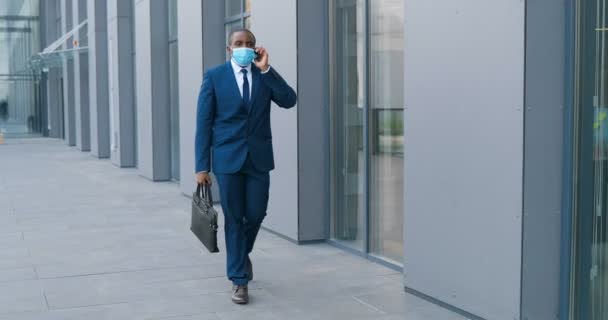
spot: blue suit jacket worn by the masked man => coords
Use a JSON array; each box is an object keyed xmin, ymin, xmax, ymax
[{"xmin": 194, "ymin": 61, "xmax": 296, "ymax": 174}]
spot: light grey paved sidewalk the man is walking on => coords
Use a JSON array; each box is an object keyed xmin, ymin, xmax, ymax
[{"xmin": 0, "ymin": 139, "xmax": 464, "ymax": 320}]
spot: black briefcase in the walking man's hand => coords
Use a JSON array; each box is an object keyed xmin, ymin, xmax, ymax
[{"xmin": 190, "ymin": 184, "xmax": 220, "ymax": 252}]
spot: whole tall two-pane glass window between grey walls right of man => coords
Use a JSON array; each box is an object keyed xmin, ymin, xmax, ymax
[{"xmin": 330, "ymin": 0, "xmax": 404, "ymax": 266}]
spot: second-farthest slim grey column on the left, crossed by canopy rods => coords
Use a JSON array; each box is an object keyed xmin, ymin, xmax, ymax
[{"xmin": 72, "ymin": 0, "xmax": 91, "ymax": 151}]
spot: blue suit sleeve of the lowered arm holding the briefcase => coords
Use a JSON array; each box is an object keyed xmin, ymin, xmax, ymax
[{"xmin": 194, "ymin": 72, "xmax": 216, "ymax": 172}]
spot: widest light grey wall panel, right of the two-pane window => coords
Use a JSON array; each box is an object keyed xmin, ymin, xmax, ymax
[{"xmin": 404, "ymin": 0, "xmax": 525, "ymax": 320}]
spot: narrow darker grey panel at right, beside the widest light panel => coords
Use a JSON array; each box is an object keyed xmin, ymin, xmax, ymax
[{"xmin": 522, "ymin": 0, "xmax": 566, "ymax": 320}]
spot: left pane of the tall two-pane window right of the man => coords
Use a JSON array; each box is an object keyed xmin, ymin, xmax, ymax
[{"xmin": 330, "ymin": 0, "xmax": 366, "ymax": 250}]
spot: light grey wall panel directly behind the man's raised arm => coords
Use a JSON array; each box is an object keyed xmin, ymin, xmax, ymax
[{"xmin": 251, "ymin": 0, "xmax": 298, "ymax": 240}]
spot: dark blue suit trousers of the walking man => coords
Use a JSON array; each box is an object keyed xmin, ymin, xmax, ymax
[{"xmin": 216, "ymin": 155, "xmax": 270, "ymax": 285}]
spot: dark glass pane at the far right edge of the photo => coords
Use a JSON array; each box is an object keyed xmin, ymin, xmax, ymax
[{"xmin": 573, "ymin": 0, "xmax": 608, "ymax": 320}]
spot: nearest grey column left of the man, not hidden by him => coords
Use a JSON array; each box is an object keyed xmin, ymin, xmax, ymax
[{"xmin": 135, "ymin": 0, "xmax": 171, "ymax": 181}]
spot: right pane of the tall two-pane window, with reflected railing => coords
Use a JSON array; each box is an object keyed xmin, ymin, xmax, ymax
[{"xmin": 369, "ymin": 0, "xmax": 404, "ymax": 264}]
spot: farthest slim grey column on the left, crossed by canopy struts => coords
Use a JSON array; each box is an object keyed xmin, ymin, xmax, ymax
[{"xmin": 61, "ymin": 0, "xmax": 76, "ymax": 146}]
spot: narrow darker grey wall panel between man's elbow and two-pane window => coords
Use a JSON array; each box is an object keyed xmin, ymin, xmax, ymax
[{"xmin": 297, "ymin": 0, "xmax": 330, "ymax": 241}]
